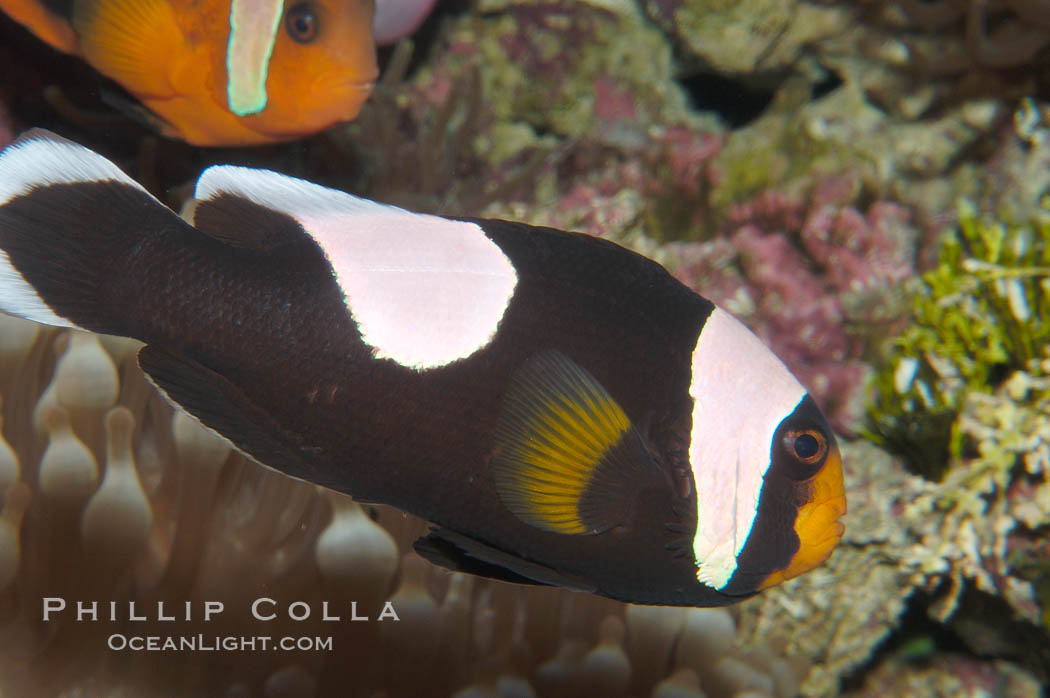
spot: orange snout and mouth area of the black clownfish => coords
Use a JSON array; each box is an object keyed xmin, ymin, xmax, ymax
[{"xmin": 758, "ymin": 444, "xmax": 846, "ymax": 589}]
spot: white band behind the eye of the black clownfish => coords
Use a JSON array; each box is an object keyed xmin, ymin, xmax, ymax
[{"xmin": 689, "ymin": 308, "xmax": 805, "ymax": 589}]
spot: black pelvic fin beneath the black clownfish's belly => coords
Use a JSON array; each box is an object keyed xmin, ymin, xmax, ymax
[{"xmin": 413, "ymin": 527, "xmax": 595, "ymax": 592}]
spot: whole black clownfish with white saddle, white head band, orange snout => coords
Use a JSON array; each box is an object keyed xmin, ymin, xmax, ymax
[{"xmin": 0, "ymin": 130, "xmax": 845, "ymax": 606}]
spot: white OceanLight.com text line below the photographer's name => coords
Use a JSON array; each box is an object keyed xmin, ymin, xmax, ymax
[{"xmin": 106, "ymin": 633, "xmax": 333, "ymax": 652}]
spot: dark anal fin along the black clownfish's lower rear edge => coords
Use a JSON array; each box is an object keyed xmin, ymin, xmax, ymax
[{"xmin": 139, "ymin": 344, "xmax": 324, "ymax": 484}]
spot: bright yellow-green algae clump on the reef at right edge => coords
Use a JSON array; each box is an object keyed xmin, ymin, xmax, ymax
[{"xmin": 868, "ymin": 199, "xmax": 1050, "ymax": 480}]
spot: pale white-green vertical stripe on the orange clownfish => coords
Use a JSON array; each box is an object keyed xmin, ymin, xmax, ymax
[{"xmin": 226, "ymin": 0, "xmax": 285, "ymax": 117}]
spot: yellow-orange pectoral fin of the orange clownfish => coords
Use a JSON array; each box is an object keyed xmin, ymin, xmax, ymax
[{"xmin": 72, "ymin": 0, "xmax": 182, "ymax": 99}]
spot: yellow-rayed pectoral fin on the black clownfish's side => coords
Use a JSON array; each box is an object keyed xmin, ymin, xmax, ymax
[{"xmin": 492, "ymin": 351, "xmax": 652, "ymax": 534}]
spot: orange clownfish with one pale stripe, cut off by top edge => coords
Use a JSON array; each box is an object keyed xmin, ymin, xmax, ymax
[{"xmin": 0, "ymin": 0, "xmax": 378, "ymax": 146}]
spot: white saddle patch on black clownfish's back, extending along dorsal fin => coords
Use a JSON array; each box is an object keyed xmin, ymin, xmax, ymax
[{"xmin": 196, "ymin": 167, "xmax": 518, "ymax": 369}]
